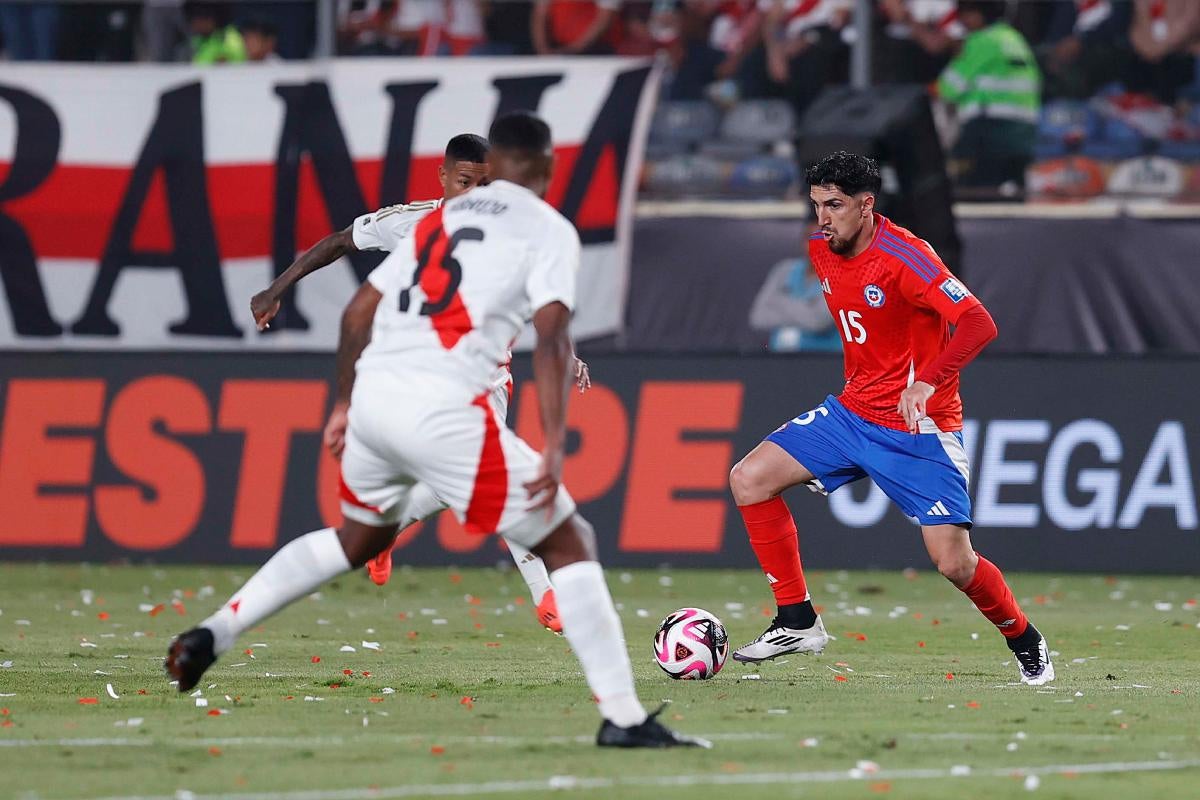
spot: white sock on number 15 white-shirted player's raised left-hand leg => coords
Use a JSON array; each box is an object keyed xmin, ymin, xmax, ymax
[{"xmin": 200, "ymin": 528, "xmax": 350, "ymax": 655}]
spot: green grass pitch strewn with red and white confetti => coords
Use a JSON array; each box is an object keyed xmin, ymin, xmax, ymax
[{"xmin": 0, "ymin": 564, "xmax": 1200, "ymax": 800}]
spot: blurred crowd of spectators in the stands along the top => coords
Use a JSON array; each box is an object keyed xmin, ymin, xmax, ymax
[{"xmin": 7, "ymin": 0, "xmax": 1200, "ymax": 199}]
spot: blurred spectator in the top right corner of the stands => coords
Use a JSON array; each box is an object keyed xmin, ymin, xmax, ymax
[{"xmin": 1124, "ymin": 0, "xmax": 1200, "ymax": 103}]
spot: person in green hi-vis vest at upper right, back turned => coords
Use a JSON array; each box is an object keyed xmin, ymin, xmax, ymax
[{"xmin": 937, "ymin": 0, "xmax": 1042, "ymax": 196}]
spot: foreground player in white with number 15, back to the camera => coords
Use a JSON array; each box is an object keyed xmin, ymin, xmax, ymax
[{"xmin": 166, "ymin": 113, "xmax": 708, "ymax": 747}]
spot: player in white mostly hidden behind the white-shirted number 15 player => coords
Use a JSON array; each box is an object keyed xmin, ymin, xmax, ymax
[{"xmin": 250, "ymin": 133, "xmax": 576, "ymax": 633}]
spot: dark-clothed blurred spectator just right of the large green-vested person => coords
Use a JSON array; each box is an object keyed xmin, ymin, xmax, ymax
[{"xmin": 1038, "ymin": 0, "xmax": 1130, "ymax": 98}]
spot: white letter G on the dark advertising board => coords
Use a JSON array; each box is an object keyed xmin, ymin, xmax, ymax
[{"xmin": 1043, "ymin": 420, "xmax": 1122, "ymax": 530}]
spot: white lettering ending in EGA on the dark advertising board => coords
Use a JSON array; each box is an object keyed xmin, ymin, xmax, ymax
[{"xmin": 825, "ymin": 419, "xmax": 1200, "ymax": 530}]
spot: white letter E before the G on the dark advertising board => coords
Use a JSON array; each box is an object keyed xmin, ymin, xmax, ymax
[{"xmin": 974, "ymin": 420, "xmax": 1050, "ymax": 528}]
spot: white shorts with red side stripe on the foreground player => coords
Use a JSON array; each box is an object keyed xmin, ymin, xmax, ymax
[{"xmin": 342, "ymin": 372, "xmax": 575, "ymax": 547}]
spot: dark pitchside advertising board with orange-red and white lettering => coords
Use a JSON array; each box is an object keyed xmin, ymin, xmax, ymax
[{"xmin": 0, "ymin": 353, "xmax": 1200, "ymax": 573}]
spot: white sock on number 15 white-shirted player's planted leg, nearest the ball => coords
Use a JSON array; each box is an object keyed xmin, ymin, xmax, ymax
[{"xmin": 551, "ymin": 561, "xmax": 646, "ymax": 728}]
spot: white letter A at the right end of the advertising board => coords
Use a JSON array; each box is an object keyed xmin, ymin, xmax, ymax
[{"xmin": 1117, "ymin": 420, "xmax": 1196, "ymax": 530}]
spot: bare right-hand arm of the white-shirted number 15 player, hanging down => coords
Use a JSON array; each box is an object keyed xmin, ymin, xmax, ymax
[{"xmin": 524, "ymin": 301, "xmax": 575, "ymax": 509}]
